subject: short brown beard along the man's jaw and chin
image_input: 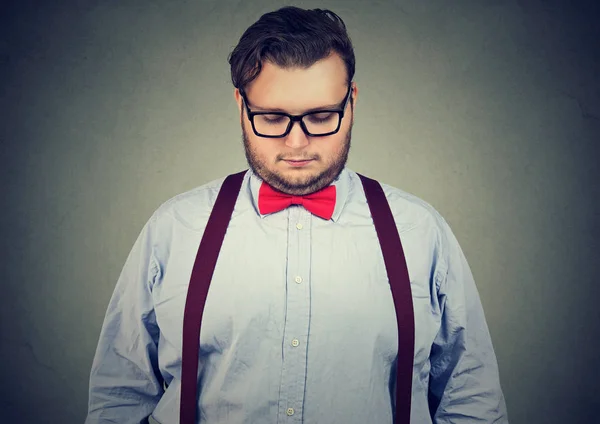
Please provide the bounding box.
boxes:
[242,122,353,196]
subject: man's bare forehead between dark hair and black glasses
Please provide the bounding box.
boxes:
[245,54,348,113]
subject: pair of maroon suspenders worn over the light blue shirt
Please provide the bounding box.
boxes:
[180,171,415,424]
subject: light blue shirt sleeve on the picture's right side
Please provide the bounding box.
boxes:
[429,222,508,424]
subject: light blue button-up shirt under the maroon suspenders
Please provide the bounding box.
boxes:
[86,168,508,424]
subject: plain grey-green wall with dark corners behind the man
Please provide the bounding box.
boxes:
[0,0,600,424]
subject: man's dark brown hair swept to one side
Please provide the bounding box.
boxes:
[228,6,355,90]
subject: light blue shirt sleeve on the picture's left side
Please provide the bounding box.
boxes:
[85,218,164,424]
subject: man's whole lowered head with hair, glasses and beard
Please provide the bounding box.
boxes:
[229,7,358,195]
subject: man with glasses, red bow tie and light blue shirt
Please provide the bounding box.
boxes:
[86,7,507,424]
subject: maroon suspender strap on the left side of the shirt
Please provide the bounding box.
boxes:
[179,171,247,424]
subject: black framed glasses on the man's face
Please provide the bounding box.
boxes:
[240,84,352,138]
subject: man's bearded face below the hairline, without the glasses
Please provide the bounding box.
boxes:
[235,54,358,195]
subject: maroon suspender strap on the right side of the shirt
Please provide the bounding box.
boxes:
[358,174,415,424]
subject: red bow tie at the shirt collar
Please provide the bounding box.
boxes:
[258,182,336,220]
